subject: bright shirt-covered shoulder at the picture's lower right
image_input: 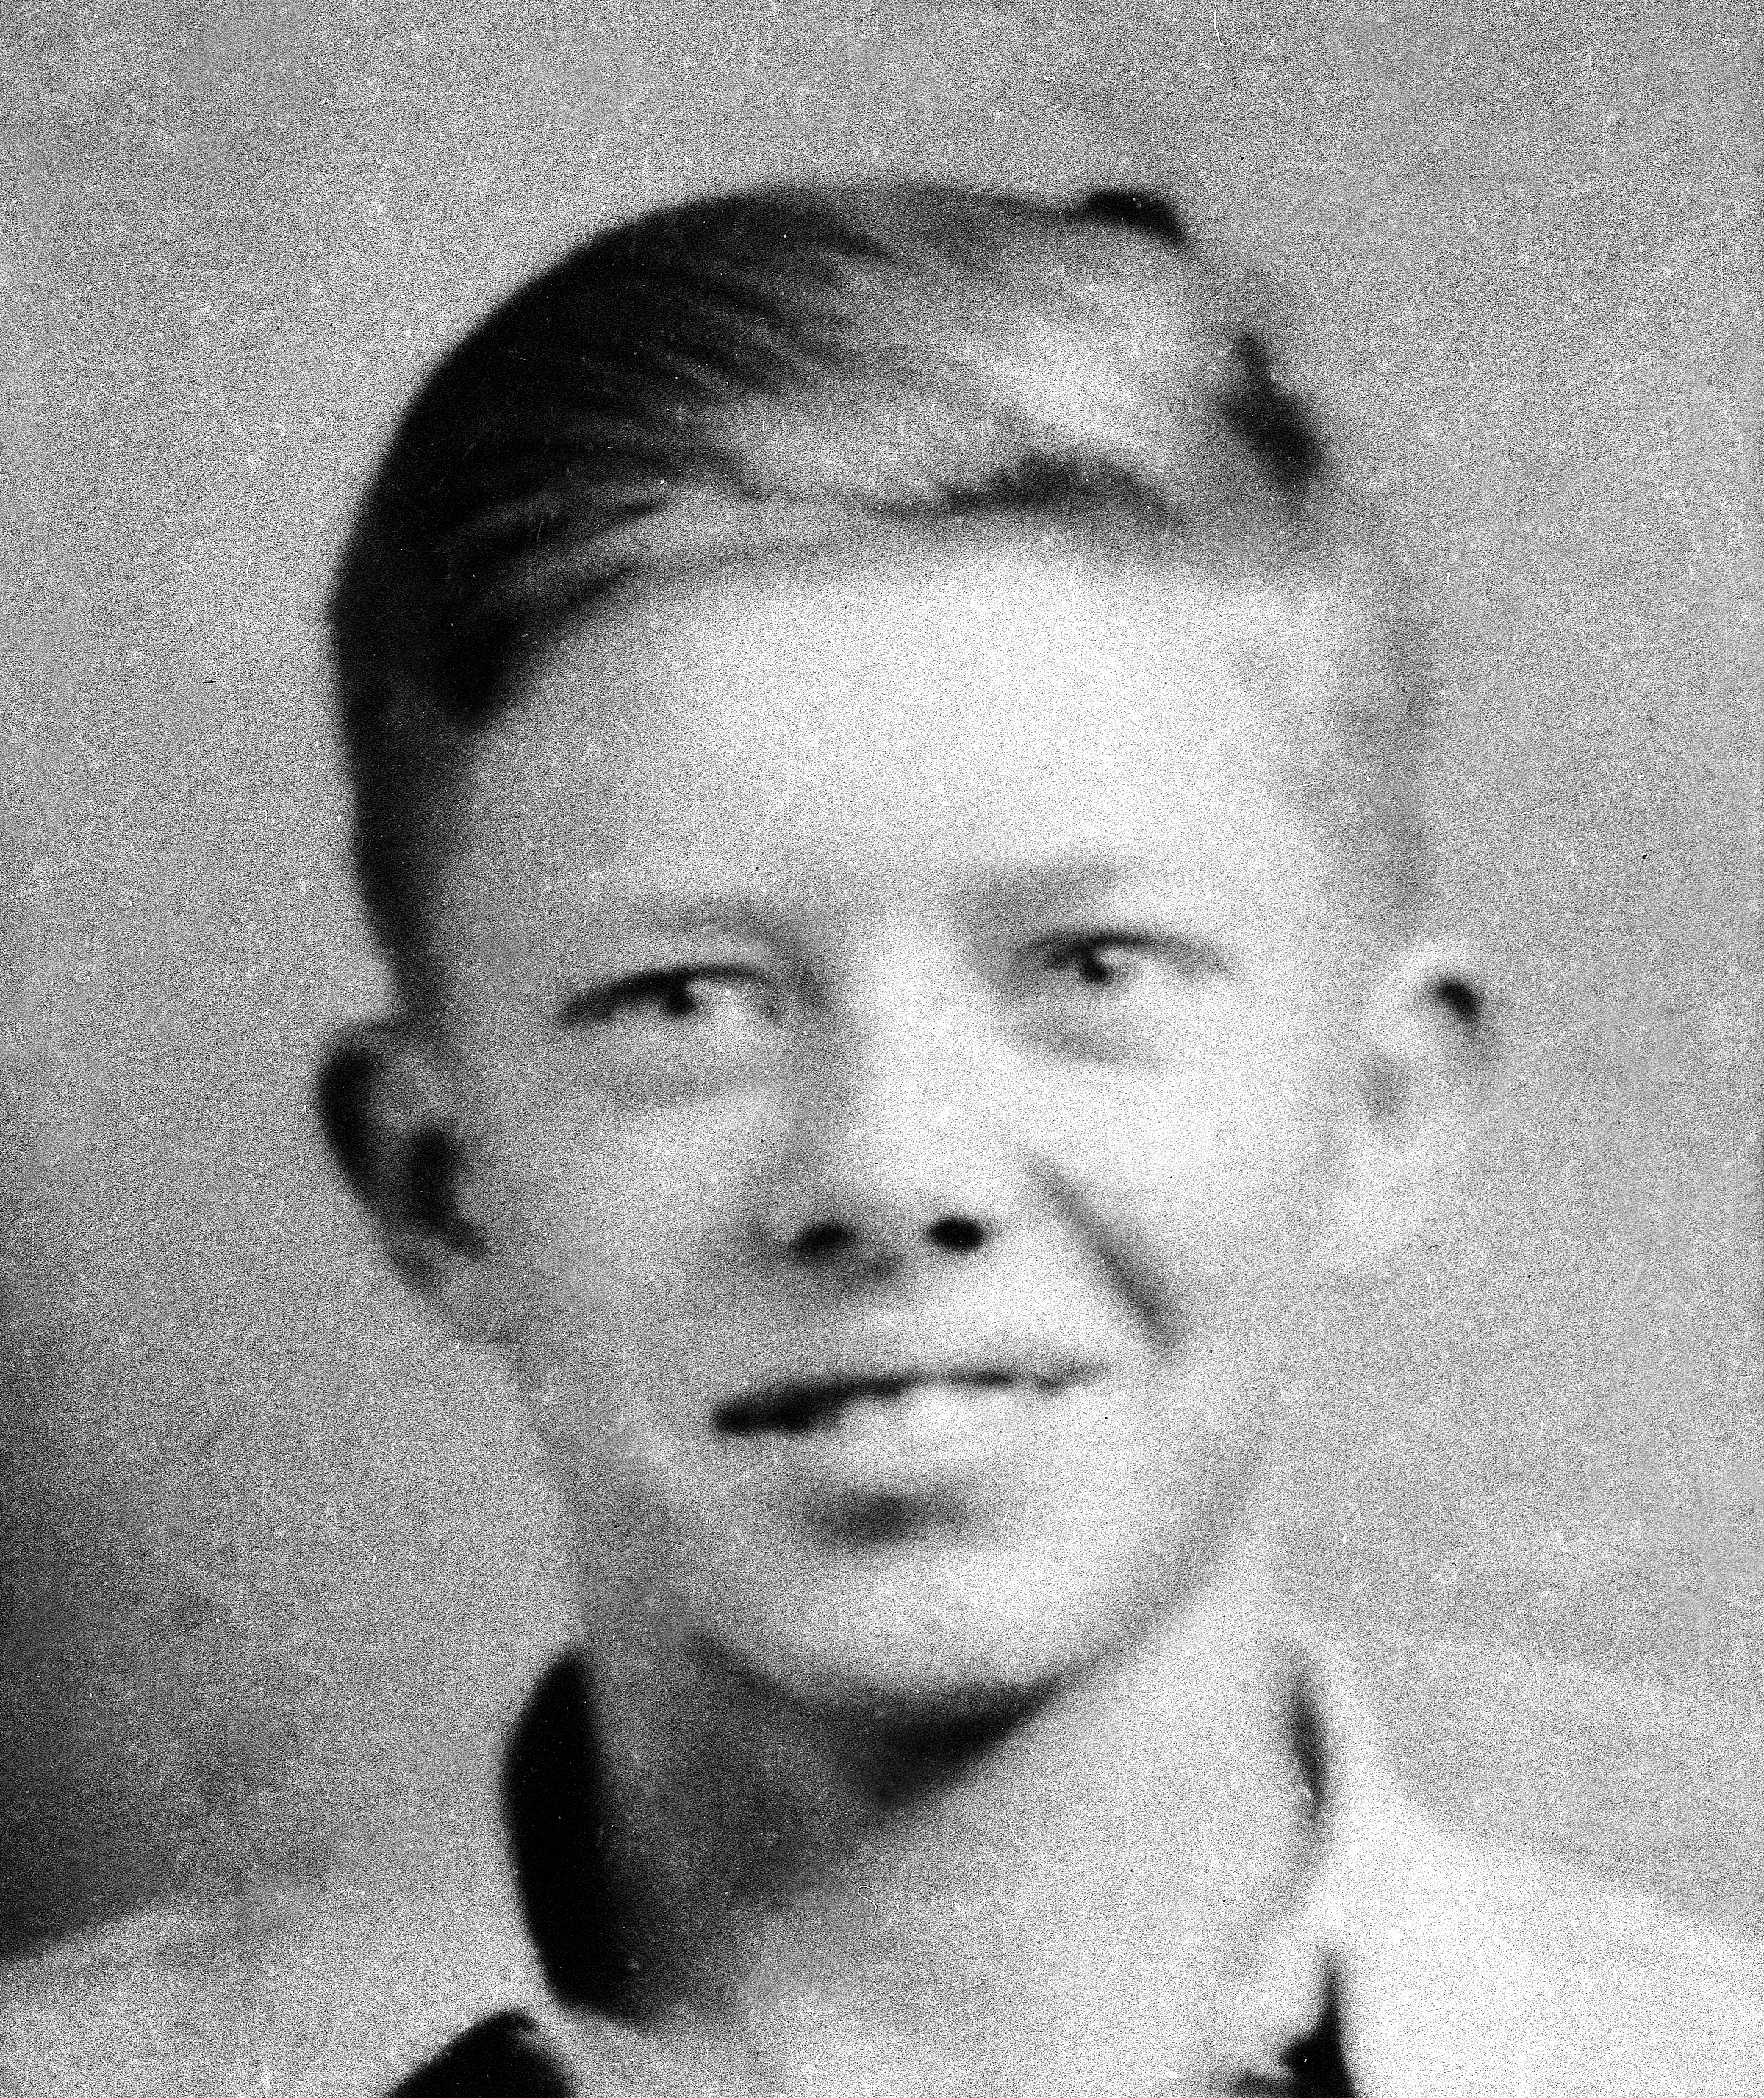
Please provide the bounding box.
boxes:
[1334,1762,1764,2098]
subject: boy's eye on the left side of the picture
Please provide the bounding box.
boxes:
[558,967,784,1086]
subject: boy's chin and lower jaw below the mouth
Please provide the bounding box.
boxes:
[566,1420,1256,1735]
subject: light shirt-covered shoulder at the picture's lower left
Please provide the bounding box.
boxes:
[0,1888,543,2098]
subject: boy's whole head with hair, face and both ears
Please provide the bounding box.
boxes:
[321,187,1477,1712]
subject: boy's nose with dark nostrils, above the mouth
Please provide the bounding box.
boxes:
[761,986,1015,1278]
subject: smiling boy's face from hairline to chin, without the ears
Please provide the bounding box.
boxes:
[398,531,1443,1712]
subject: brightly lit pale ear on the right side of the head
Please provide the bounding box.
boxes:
[1324,940,1489,1273]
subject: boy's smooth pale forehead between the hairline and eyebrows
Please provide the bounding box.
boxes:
[444,529,1376,948]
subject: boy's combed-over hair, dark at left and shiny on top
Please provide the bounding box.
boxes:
[329,182,1422,997]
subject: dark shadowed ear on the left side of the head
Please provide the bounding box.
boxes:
[312,1015,508,1341]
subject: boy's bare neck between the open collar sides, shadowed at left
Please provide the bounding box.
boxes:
[566,1540,1307,2098]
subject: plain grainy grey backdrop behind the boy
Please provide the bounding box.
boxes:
[0,0,1764,1945]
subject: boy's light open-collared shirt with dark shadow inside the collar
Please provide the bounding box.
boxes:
[0,1649,1764,2098]
